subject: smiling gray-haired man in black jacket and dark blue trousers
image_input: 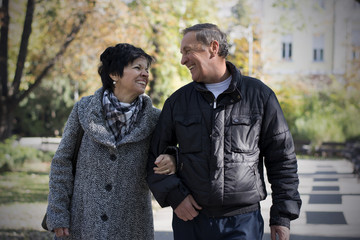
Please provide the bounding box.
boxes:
[147,23,301,240]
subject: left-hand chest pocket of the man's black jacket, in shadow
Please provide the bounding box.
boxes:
[175,115,201,153]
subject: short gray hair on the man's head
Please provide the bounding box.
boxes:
[182,23,229,58]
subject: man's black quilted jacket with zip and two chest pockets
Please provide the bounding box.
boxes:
[147,62,301,227]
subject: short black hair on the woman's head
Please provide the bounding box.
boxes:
[98,43,154,91]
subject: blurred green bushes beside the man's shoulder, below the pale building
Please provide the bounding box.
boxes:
[277,78,360,146]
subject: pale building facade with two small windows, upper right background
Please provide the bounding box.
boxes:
[252,0,360,81]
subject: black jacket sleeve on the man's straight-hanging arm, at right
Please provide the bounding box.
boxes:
[260,92,301,228]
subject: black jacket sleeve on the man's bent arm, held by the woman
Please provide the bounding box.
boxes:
[147,100,189,209]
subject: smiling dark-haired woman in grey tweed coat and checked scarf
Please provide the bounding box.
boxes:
[46,43,175,240]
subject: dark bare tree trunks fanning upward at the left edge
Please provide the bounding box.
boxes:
[0,0,95,141]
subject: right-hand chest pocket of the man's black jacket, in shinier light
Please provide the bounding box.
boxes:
[230,115,261,152]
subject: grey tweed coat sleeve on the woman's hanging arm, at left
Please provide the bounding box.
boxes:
[47,103,81,230]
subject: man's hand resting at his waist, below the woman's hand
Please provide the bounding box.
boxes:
[174,195,201,222]
